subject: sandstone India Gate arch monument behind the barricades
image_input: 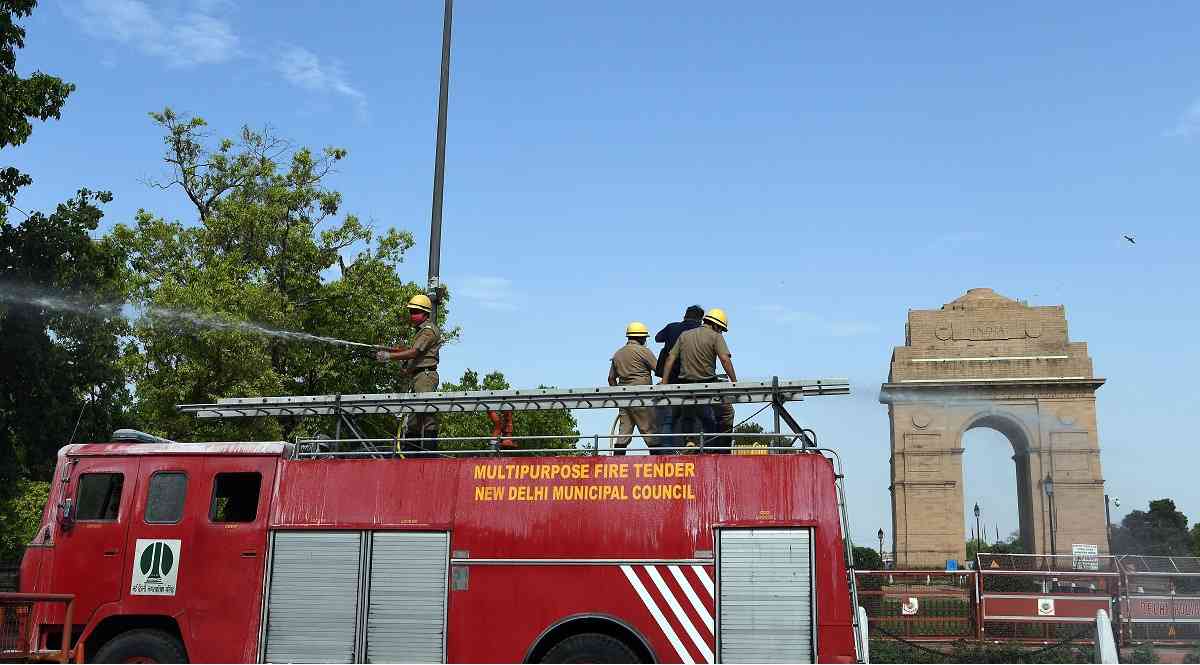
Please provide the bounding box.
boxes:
[880,288,1108,568]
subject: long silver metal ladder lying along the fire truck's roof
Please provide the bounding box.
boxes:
[178,378,850,418]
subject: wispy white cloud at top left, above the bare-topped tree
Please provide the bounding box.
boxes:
[67,0,238,67]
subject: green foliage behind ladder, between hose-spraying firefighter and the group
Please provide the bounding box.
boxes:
[438,370,580,450]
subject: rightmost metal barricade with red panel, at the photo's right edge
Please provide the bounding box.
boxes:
[1117,555,1200,643]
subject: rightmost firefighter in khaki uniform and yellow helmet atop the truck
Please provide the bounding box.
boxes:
[662,307,738,447]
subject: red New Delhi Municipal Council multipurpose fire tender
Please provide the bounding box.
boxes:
[20,374,862,664]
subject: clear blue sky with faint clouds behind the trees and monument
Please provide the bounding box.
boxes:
[6,0,1200,544]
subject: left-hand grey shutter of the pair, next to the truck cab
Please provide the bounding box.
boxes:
[265,532,362,663]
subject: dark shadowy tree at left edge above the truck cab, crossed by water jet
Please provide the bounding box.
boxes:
[0,190,130,484]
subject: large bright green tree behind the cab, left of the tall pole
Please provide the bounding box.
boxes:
[113,108,436,438]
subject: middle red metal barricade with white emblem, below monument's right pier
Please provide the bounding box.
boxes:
[976,552,1120,642]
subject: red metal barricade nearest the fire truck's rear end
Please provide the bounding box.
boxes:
[854,570,977,642]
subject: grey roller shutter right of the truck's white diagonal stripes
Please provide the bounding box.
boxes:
[716,528,815,663]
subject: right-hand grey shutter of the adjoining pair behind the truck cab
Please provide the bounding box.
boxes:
[366,532,450,663]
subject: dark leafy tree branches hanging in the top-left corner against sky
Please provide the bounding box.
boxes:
[0,0,74,213]
